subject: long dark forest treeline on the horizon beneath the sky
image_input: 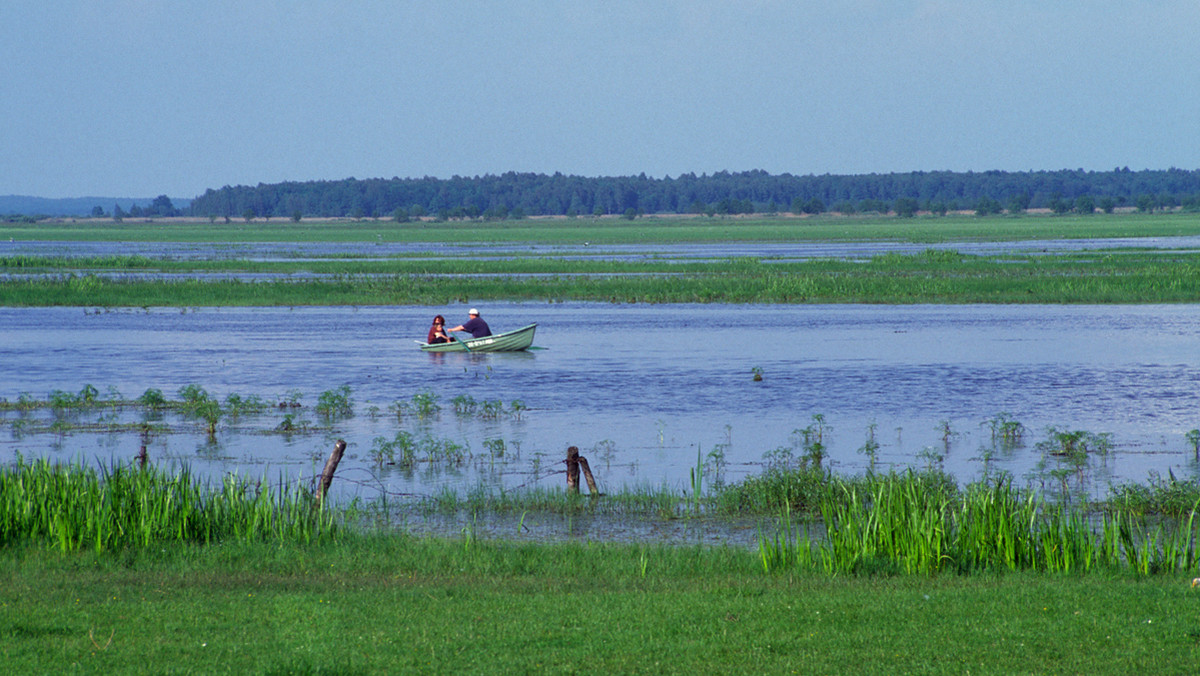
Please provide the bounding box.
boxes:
[188,168,1200,221]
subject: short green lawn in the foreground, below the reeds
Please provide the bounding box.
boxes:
[0,534,1200,674]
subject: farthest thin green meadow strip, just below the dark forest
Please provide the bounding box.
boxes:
[7,213,1200,245]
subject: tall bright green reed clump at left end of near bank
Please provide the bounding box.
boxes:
[0,459,338,551]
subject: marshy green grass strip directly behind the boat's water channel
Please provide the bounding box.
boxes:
[7,252,1200,307]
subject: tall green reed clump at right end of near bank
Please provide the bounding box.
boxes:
[758,471,1200,575]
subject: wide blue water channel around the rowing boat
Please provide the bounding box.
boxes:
[0,303,1200,509]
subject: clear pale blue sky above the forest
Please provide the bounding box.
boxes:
[0,0,1200,198]
